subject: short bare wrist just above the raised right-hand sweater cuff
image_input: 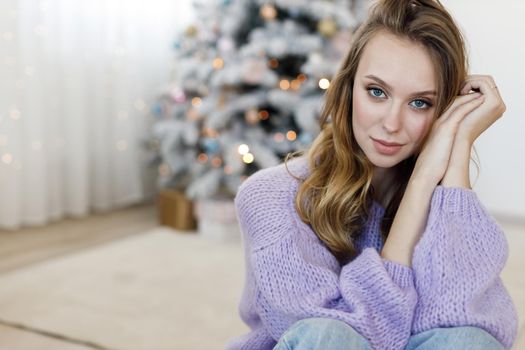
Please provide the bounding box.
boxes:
[441,137,472,189]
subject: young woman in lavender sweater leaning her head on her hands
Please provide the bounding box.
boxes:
[228,0,517,350]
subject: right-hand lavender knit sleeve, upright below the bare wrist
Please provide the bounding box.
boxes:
[412,186,517,349]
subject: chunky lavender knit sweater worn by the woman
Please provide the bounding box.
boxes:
[227,157,517,350]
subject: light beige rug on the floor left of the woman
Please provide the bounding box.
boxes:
[0,228,246,350]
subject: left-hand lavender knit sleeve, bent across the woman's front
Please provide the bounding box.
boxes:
[235,167,416,350]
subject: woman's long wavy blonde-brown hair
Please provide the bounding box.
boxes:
[286,0,468,263]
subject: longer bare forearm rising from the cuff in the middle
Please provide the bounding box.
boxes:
[381,177,435,266]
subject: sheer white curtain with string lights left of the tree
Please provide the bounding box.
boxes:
[0,0,183,229]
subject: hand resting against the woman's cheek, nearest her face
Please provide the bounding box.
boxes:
[410,91,485,190]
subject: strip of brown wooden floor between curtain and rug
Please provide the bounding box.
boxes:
[0,204,158,273]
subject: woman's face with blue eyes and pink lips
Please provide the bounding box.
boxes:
[352,31,436,168]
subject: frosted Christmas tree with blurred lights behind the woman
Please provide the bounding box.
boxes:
[147,0,367,198]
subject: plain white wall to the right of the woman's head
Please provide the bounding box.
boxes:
[442,0,525,219]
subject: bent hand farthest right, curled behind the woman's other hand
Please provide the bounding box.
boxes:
[457,75,506,146]
